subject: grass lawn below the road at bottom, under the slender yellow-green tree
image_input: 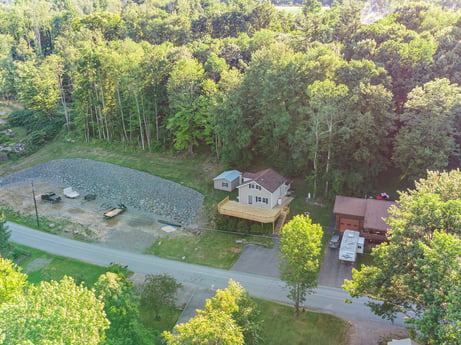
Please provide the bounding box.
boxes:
[255,299,350,345]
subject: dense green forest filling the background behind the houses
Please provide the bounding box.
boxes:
[0,0,461,197]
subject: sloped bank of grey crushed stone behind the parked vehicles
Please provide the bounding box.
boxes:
[0,159,203,225]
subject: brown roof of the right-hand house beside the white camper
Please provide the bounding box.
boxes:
[333,195,397,231]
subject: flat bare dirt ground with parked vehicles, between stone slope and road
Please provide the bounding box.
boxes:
[0,182,178,252]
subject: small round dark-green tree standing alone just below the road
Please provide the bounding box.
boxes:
[140,273,182,320]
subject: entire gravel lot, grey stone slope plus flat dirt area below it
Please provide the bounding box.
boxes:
[0,159,203,252]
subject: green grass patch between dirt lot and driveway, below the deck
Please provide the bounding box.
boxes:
[147,231,273,269]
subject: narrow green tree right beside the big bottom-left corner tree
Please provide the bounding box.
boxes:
[94,272,141,345]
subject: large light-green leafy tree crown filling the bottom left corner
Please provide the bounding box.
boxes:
[0,277,109,345]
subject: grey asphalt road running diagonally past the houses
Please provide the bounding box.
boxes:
[7,222,403,326]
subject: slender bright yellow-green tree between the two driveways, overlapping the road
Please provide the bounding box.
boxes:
[280,215,323,316]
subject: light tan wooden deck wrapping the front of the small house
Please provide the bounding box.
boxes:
[218,197,293,223]
